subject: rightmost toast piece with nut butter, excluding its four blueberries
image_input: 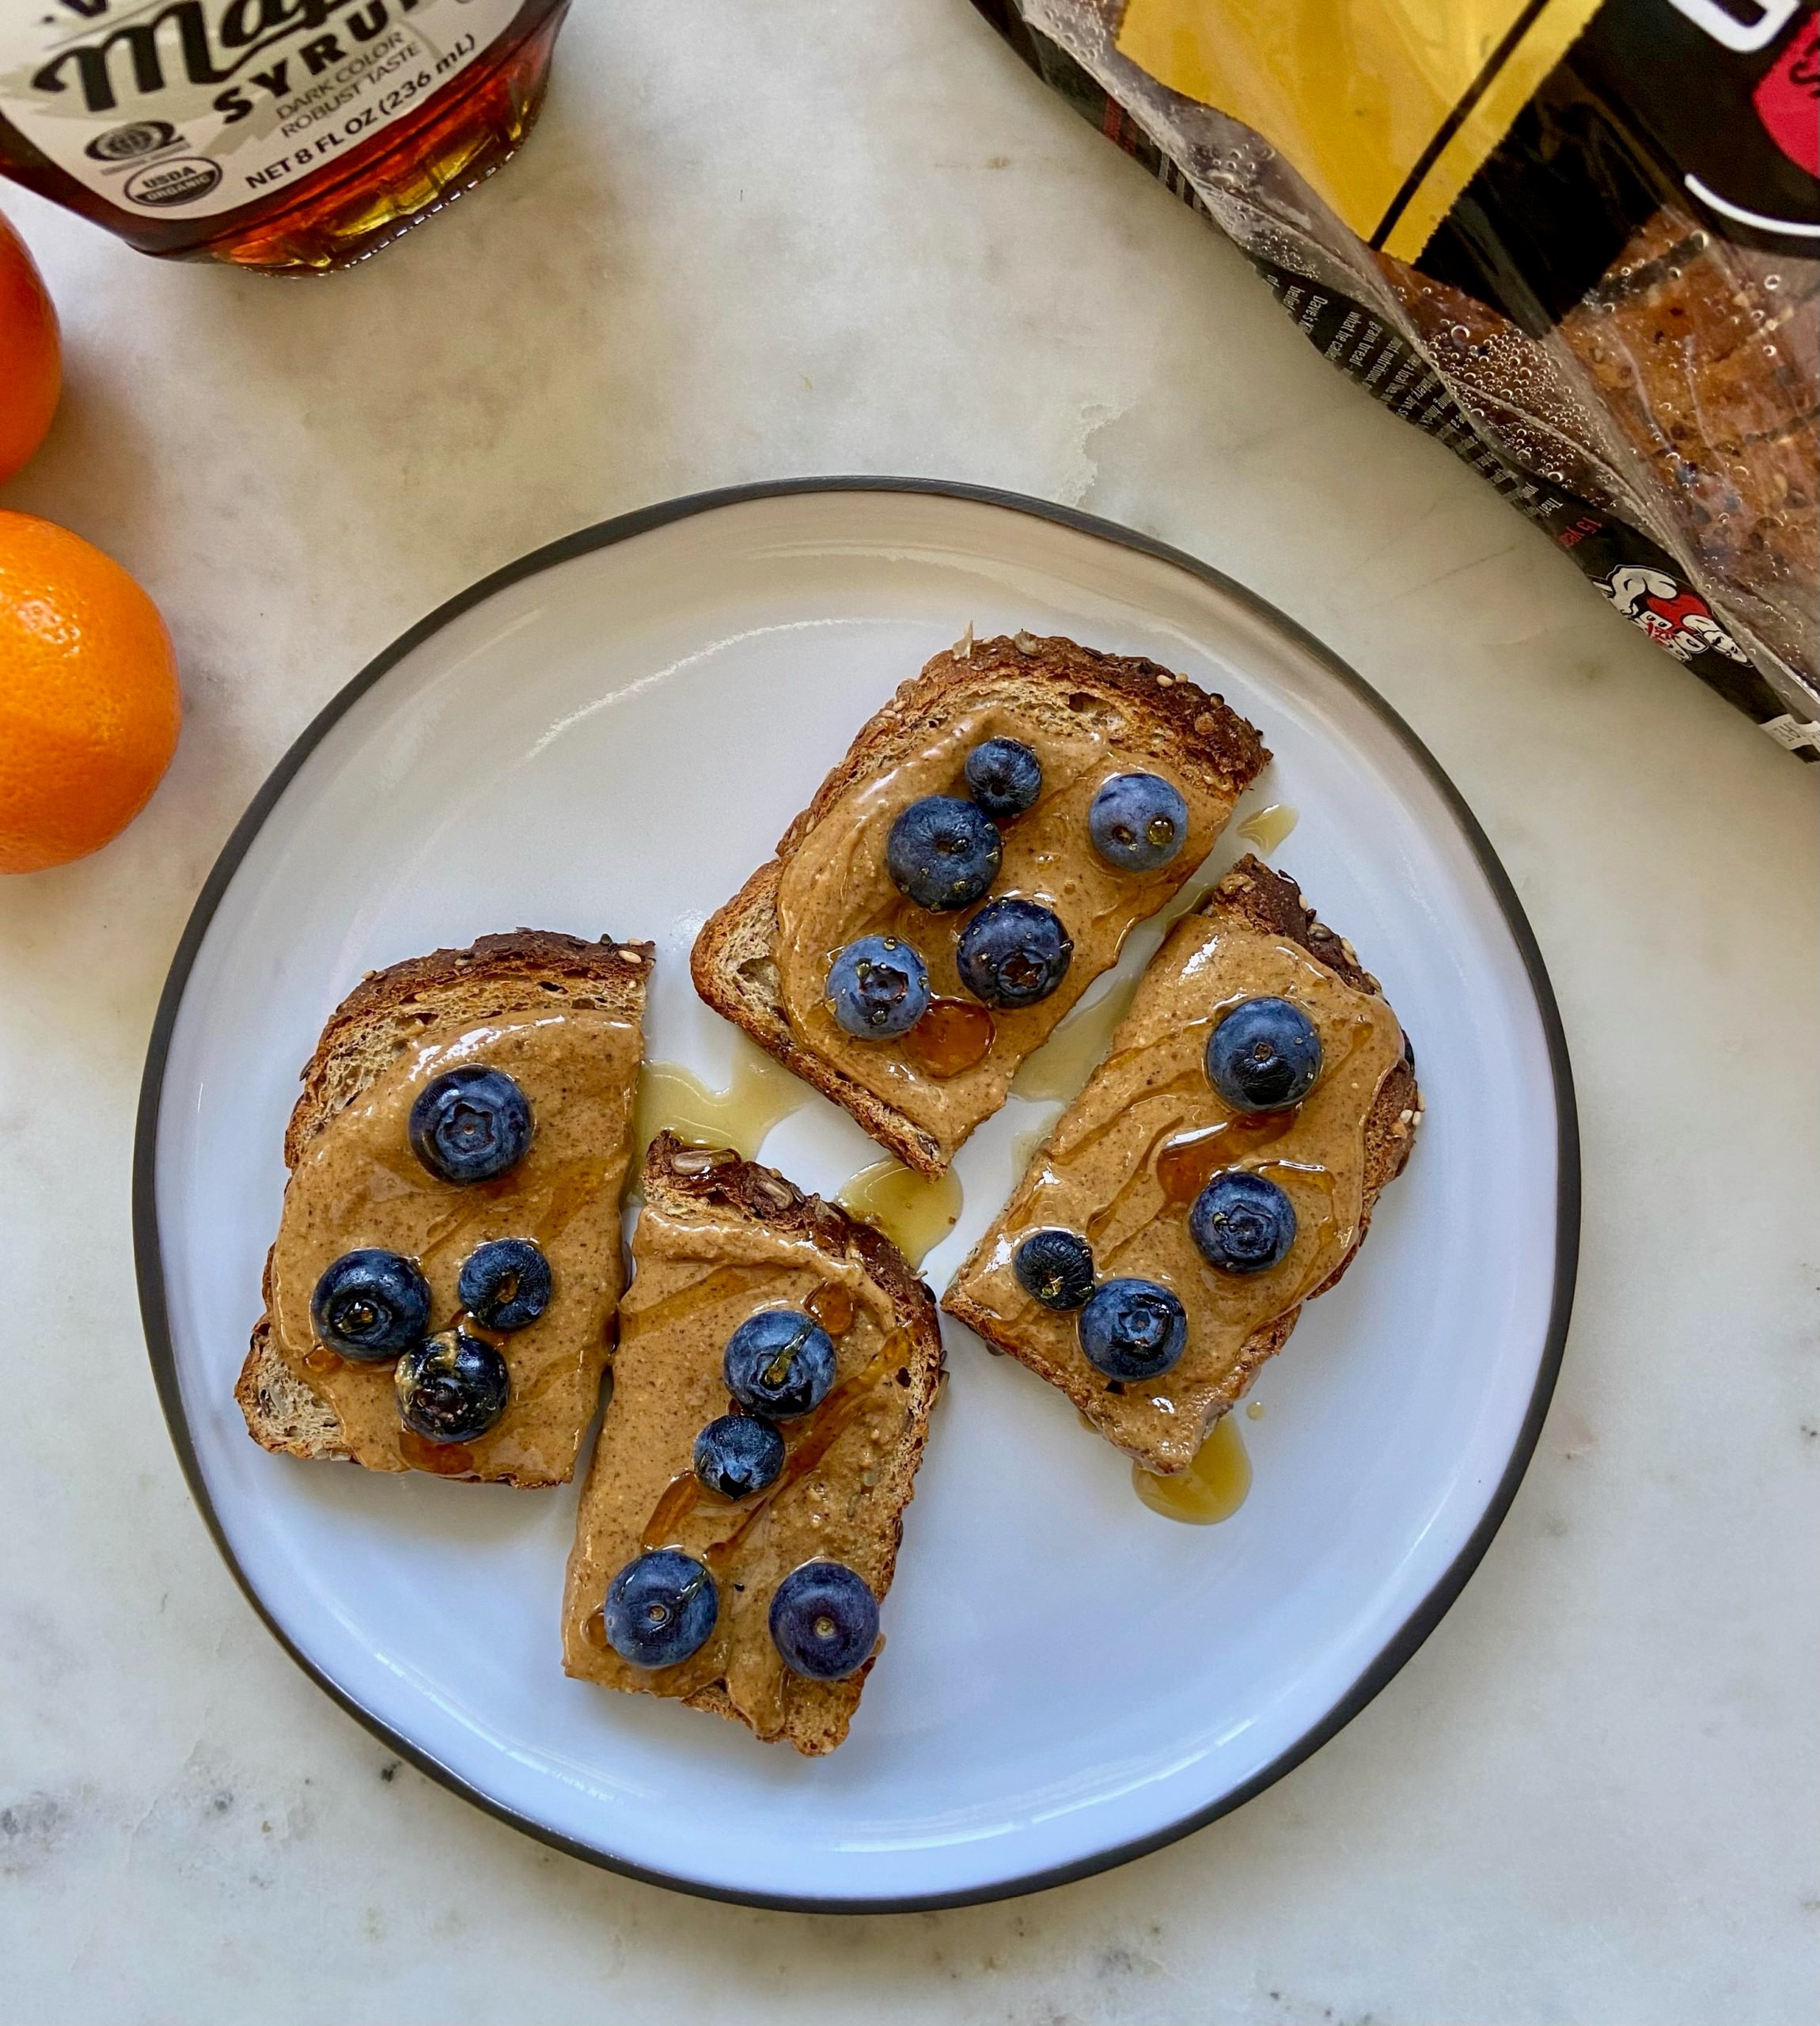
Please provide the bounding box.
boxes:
[942,857,1423,1473]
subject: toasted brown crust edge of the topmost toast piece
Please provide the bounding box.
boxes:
[689,634,1271,1177]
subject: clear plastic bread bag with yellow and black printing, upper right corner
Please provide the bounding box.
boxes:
[975,0,1820,760]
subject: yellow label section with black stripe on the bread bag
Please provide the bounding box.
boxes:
[1119,0,1599,261]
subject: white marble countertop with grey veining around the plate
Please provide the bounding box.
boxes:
[0,0,1820,2026]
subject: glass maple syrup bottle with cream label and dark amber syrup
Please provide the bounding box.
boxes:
[0,0,567,274]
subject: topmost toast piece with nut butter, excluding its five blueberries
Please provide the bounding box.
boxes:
[689,634,1268,1175]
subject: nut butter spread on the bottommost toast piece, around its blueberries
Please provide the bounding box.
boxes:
[563,1204,912,1738]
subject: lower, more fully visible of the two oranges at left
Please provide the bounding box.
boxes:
[0,513,183,873]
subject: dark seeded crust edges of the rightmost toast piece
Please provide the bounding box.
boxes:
[942,855,1423,1475]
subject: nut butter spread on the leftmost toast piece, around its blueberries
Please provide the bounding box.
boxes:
[267,1007,640,1483]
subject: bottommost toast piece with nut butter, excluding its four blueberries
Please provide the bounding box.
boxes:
[563,1133,942,1755]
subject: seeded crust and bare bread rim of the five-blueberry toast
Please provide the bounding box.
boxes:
[689,632,1271,1175]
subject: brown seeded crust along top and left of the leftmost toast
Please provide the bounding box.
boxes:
[233,928,654,1483]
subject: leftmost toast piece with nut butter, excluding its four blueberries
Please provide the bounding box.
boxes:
[235,928,653,1485]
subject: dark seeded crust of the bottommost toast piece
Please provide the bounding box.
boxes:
[587,1133,945,1759]
